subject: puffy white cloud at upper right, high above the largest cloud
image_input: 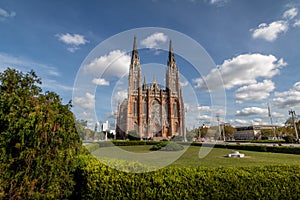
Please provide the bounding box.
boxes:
[251,20,289,42]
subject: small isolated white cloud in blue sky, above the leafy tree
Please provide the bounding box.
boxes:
[55,33,89,53]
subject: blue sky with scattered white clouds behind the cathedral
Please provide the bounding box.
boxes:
[0,0,300,129]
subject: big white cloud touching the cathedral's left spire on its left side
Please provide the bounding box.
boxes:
[83,50,130,77]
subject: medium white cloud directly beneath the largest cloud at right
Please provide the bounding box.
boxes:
[235,80,275,103]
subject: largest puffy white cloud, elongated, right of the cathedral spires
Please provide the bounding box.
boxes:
[194,53,286,90]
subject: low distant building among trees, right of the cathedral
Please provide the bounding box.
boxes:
[234,125,275,140]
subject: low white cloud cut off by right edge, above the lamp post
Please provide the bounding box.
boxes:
[273,82,300,108]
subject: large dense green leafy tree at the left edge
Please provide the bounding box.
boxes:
[0,68,81,199]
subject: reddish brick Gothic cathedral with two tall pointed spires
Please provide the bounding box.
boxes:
[116,37,185,139]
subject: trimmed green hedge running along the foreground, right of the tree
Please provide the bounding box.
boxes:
[73,156,300,199]
